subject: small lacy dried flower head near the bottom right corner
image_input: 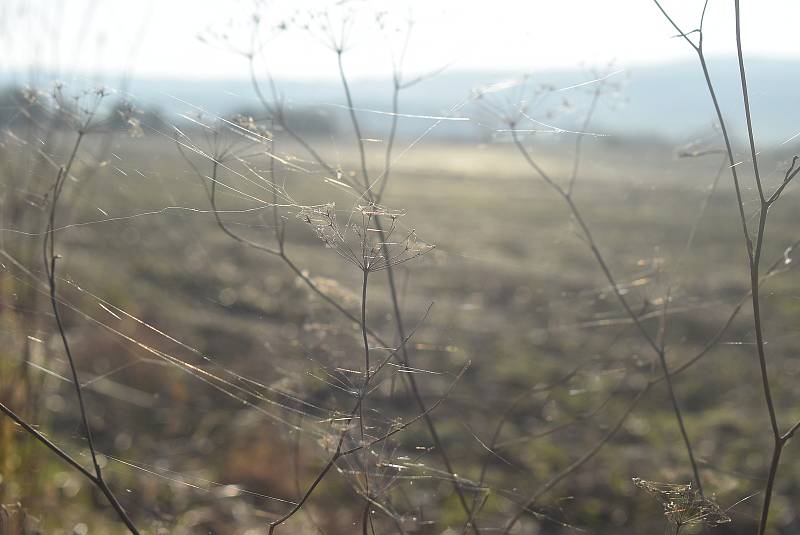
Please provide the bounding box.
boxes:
[633,477,731,528]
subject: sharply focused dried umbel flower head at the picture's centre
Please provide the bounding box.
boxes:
[298,203,434,272]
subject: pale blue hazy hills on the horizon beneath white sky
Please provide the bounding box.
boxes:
[0,58,800,143]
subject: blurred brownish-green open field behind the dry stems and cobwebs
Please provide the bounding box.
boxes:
[0,127,800,535]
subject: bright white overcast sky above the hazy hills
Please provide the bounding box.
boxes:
[0,0,800,78]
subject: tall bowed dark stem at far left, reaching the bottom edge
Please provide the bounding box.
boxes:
[38,130,139,535]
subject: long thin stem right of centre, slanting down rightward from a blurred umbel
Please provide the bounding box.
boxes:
[511,130,702,494]
